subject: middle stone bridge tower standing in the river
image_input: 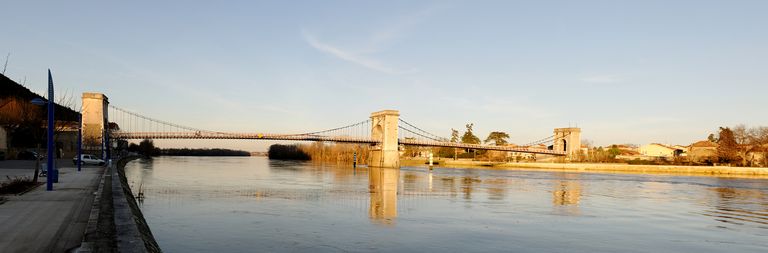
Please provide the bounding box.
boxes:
[368,110,400,168]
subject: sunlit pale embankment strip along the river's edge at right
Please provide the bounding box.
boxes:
[400,159,768,179]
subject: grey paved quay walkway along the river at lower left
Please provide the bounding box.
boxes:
[0,161,104,252]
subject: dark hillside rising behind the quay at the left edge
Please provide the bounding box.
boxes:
[0,74,80,121]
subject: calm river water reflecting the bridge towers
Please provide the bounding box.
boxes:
[126,157,768,252]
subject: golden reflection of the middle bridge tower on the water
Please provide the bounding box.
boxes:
[368,168,400,225]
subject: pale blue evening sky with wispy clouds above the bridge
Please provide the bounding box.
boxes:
[0,0,768,150]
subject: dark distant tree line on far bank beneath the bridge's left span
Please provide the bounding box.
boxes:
[127,140,251,156]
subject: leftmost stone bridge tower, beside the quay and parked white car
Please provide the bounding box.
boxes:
[80,92,109,160]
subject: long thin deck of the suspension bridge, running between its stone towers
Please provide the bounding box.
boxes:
[111,132,566,156]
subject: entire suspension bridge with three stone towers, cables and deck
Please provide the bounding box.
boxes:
[83,93,580,167]
